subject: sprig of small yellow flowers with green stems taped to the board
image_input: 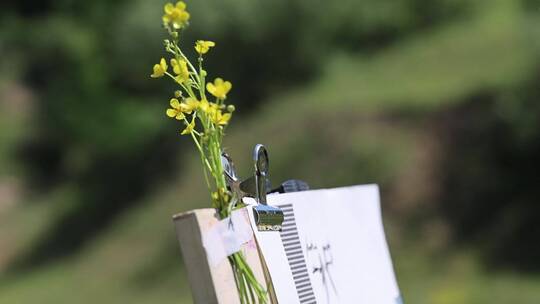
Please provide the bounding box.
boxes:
[150,1,267,303]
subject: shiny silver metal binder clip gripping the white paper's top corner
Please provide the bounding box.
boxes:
[221,144,284,231]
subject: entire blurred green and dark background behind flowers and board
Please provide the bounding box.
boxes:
[0,0,540,304]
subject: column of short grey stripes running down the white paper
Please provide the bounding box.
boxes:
[278,204,317,304]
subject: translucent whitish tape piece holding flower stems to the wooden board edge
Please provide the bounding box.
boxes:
[202,209,253,266]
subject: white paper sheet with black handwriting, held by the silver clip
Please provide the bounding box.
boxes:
[247,185,402,304]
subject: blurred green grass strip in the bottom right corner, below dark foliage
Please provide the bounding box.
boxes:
[394,247,540,304]
